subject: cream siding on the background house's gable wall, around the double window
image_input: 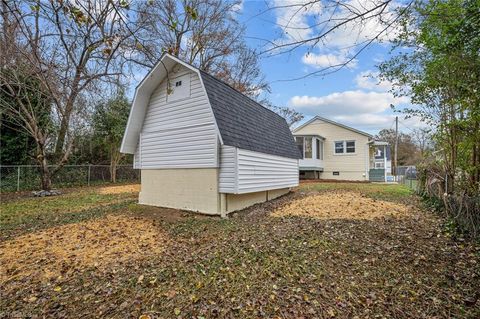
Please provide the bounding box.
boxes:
[294,119,369,181]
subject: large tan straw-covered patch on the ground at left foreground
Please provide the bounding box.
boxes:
[0,215,168,283]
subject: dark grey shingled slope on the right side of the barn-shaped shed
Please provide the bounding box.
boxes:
[200,71,301,159]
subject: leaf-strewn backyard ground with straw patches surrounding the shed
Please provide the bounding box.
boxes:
[0,183,480,318]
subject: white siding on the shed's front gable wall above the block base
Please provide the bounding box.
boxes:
[135,67,218,169]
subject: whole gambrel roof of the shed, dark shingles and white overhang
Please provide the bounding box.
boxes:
[121,54,301,159]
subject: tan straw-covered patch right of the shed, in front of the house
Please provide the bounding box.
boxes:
[272,191,409,220]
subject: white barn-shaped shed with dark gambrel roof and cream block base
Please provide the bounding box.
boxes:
[121,54,300,215]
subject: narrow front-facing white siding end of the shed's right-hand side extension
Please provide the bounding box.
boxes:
[219,145,237,193]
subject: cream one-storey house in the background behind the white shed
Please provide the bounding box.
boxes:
[293,116,391,181]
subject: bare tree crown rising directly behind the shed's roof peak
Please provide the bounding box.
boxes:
[133,0,269,97]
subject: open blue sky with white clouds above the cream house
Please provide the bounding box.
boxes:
[235,0,420,134]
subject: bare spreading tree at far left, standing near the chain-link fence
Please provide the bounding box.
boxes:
[0,0,131,189]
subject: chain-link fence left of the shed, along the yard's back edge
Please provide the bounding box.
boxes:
[0,165,140,192]
